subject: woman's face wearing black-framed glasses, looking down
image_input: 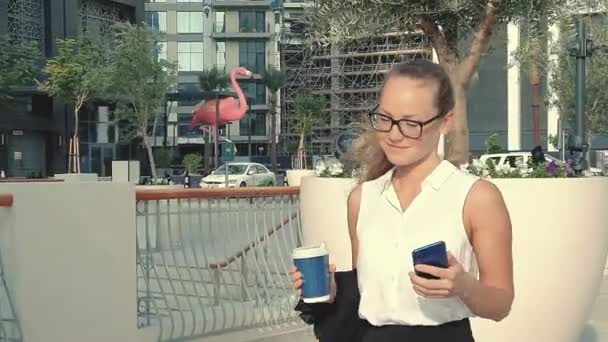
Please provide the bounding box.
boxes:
[372,76,452,166]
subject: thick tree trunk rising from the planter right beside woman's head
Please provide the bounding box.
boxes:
[445,82,469,166]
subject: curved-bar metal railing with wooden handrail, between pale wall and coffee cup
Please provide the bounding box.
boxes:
[136,188,301,341]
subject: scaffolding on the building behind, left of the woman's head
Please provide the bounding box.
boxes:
[280,28,432,155]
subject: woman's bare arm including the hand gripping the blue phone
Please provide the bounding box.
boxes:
[410,180,514,321]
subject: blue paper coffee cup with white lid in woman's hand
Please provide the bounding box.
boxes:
[293,245,330,303]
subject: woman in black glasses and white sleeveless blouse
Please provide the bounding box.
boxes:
[291,61,514,342]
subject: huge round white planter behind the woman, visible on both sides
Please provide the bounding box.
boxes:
[300,177,608,342]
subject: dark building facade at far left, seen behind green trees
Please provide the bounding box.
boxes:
[0,0,144,177]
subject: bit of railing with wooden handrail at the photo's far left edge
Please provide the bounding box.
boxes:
[0,194,23,342]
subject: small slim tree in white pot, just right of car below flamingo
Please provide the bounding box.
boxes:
[287,94,327,186]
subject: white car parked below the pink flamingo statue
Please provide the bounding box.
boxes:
[200,163,277,188]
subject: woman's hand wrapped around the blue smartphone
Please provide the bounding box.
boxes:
[410,252,475,298]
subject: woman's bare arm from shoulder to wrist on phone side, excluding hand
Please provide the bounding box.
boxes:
[460,180,515,321]
